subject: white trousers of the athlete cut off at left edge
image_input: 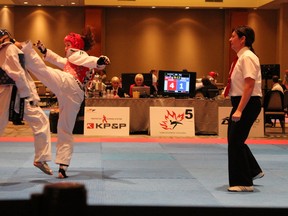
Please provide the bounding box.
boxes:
[0,85,51,162]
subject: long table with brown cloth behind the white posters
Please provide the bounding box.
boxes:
[85,98,231,135]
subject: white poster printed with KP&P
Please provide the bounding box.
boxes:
[84,107,130,136]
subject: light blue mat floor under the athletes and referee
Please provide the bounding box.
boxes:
[0,142,288,207]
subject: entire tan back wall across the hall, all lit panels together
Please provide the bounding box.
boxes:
[0,7,288,83]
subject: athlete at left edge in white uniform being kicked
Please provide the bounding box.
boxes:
[0,29,53,175]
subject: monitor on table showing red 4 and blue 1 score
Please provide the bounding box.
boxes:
[158,70,196,98]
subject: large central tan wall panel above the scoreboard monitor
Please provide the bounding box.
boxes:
[106,9,224,81]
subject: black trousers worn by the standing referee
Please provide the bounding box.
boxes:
[227,96,261,187]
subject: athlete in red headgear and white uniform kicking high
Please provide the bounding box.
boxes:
[21,27,110,178]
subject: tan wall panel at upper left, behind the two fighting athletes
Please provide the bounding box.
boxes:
[14,7,85,56]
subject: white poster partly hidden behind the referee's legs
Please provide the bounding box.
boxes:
[218,107,264,138]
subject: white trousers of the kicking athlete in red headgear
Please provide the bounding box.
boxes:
[22,43,84,165]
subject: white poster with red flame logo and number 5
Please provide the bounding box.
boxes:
[150,107,195,137]
